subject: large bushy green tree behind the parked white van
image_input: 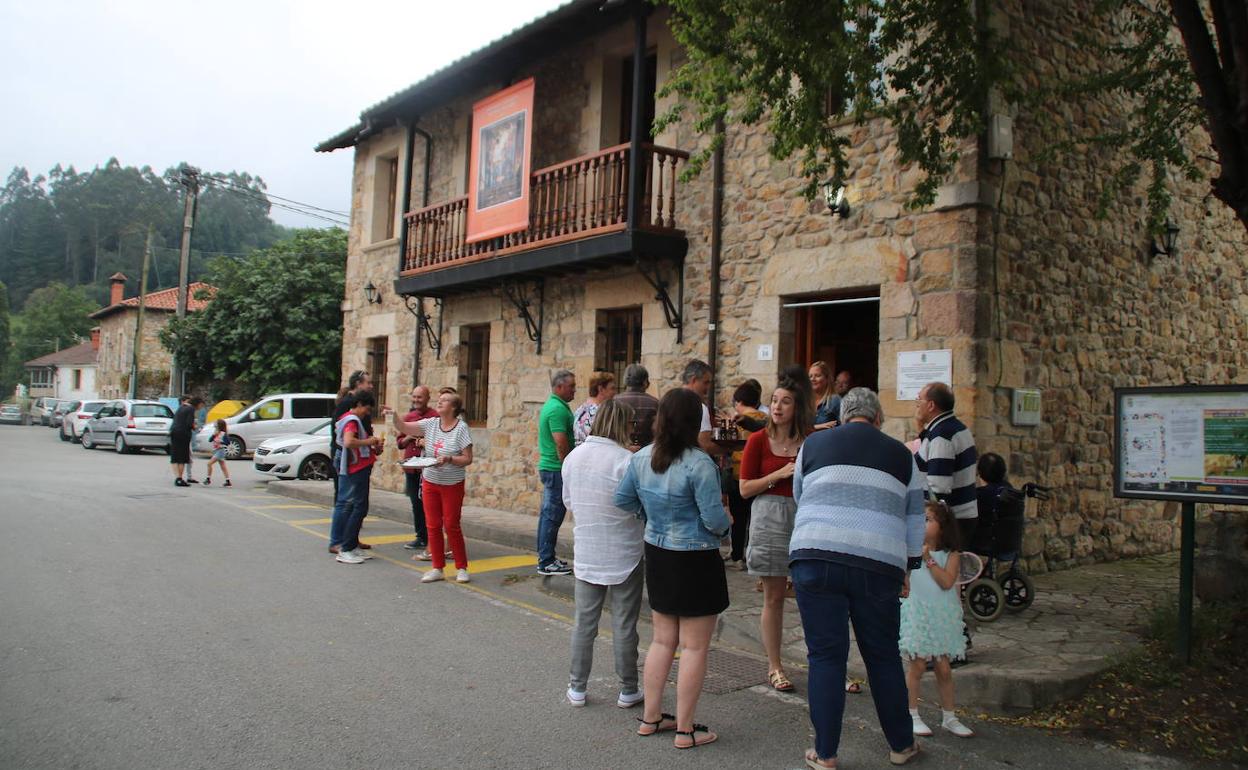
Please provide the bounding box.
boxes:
[161,228,347,397]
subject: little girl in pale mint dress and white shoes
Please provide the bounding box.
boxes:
[897,500,975,738]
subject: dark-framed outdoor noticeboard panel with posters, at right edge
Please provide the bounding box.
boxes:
[1113,384,1248,505]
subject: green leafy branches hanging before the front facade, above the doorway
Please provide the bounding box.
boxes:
[656,0,1010,205]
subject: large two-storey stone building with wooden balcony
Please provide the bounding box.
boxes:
[317,0,1248,570]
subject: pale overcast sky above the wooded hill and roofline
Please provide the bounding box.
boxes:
[0,0,562,227]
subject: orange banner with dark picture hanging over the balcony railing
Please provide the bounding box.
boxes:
[468,77,534,243]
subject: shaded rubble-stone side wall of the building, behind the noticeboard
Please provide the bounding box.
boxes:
[975,0,1248,569]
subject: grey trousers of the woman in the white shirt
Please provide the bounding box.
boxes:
[572,559,645,694]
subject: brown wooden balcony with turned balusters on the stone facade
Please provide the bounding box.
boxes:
[398,144,689,296]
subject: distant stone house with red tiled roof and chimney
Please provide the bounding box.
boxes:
[91,273,212,398]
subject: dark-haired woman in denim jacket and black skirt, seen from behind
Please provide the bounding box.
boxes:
[615,388,731,749]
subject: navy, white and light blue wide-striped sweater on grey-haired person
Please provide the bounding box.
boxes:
[789,422,925,580]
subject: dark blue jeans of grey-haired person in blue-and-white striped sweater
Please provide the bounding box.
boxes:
[790,559,915,759]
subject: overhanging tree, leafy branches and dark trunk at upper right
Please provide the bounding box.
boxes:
[655,0,1248,234]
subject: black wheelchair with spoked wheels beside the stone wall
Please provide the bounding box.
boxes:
[962,483,1051,623]
